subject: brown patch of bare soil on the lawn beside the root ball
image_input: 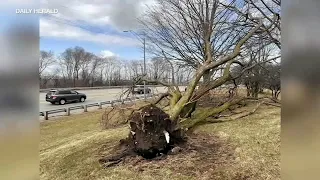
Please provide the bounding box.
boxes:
[100,133,247,180]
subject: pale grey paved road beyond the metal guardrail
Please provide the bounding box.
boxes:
[39,86,184,112]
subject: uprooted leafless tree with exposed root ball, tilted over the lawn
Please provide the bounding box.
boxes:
[99,0,279,165]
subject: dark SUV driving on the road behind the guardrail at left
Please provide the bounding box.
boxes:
[46,90,87,105]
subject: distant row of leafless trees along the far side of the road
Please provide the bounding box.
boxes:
[39,47,193,88]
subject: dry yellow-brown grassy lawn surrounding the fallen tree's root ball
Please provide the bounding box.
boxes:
[40,105,280,180]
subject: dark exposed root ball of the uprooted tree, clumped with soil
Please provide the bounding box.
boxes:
[100,105,185,164]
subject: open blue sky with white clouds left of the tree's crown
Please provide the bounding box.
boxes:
[40,0,154,60]
